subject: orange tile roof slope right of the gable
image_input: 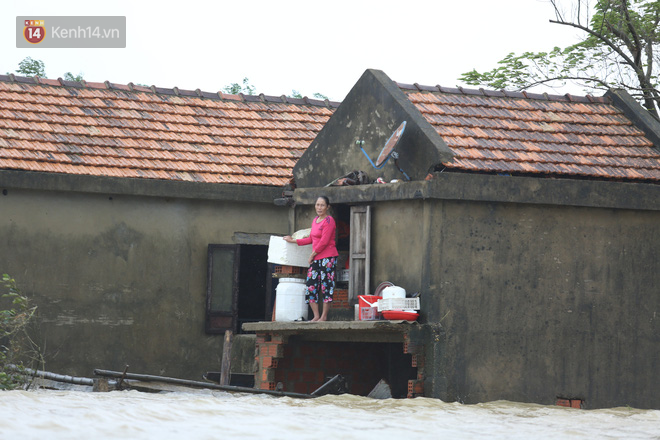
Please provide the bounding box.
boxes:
[397,84,660,182]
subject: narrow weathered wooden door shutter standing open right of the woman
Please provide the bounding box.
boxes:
[348,205,371,301]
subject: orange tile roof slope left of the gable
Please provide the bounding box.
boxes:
[0,75,339,186]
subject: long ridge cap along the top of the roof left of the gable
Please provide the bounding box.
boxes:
[0,73,341,108]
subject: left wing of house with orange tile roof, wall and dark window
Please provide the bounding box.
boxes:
[0,75,337,379]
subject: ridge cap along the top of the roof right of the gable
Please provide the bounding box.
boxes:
[394,81,611,104]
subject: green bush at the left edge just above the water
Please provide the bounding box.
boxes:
[0,274,43,390]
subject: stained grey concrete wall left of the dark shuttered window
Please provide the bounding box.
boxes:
[0,176,288,379]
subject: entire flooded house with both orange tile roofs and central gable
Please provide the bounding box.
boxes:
[0,70,660,408]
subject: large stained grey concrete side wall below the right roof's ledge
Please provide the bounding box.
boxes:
[423,201,660,408]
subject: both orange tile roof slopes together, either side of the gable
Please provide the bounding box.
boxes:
[5,75,660,186]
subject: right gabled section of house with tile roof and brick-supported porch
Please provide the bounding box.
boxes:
[244,70,660,408]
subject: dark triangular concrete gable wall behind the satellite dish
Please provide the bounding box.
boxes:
[293,69,453,188]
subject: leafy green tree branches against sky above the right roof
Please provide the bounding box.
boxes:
[460,0,660,117]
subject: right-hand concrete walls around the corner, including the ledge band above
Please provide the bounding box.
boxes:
[296,174,660,408]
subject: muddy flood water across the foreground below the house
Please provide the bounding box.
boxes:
[0,390,660,440]
